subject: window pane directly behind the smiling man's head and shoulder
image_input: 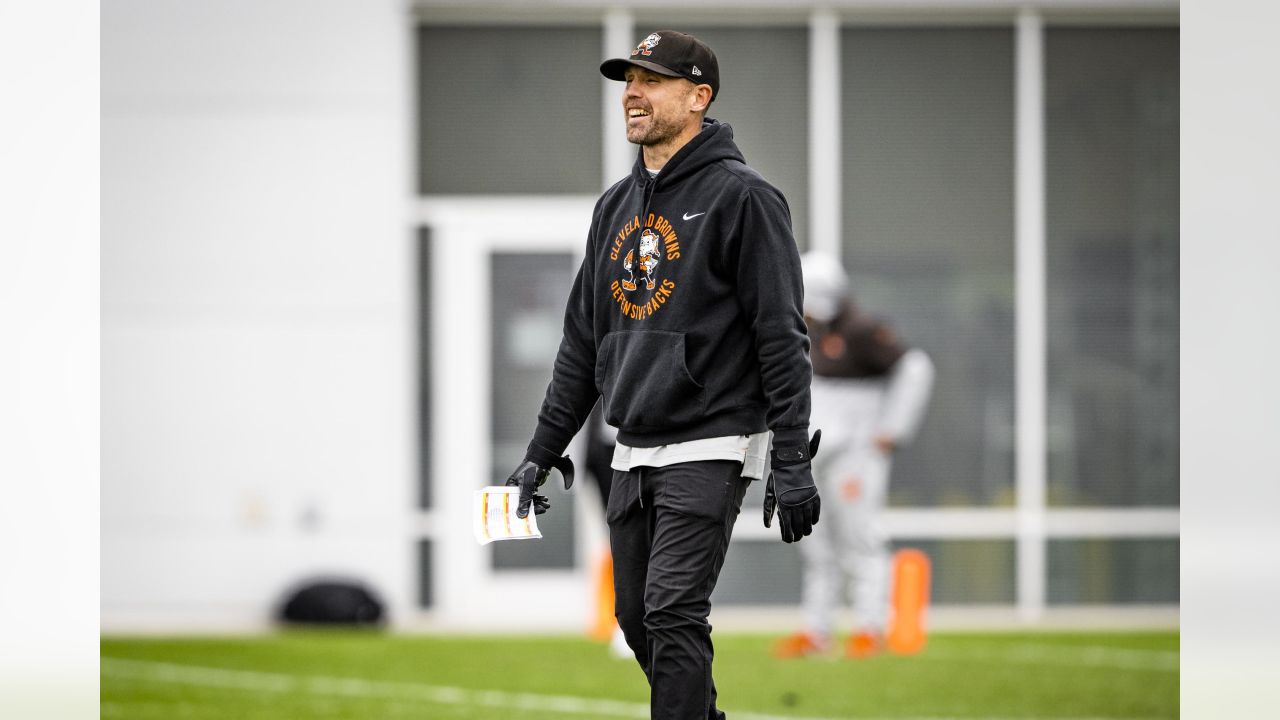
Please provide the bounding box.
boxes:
[660,23,809,249]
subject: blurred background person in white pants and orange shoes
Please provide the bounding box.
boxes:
[774,251,933,657]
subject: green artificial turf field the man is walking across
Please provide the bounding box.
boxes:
[101,630,1179,720]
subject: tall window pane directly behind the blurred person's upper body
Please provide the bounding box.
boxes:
[841,28,1014,506]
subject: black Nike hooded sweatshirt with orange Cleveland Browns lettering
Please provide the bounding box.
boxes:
[529,119,812,468]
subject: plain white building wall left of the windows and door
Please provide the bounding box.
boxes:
[101,0,416,630]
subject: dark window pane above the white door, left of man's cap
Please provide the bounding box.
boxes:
[417,26,603,195]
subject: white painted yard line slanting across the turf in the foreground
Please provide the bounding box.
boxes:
[101,657,1172,720]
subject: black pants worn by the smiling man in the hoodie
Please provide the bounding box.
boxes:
[605,460,750,720]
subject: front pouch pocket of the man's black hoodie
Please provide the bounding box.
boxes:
[595,331,707,428]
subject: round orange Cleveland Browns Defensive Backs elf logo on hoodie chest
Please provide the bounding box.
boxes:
[609,213,680,320]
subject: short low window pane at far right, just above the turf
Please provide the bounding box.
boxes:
[1048,538,1179,605]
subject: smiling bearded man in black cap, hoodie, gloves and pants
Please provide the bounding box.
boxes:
[507,31,819,720]
